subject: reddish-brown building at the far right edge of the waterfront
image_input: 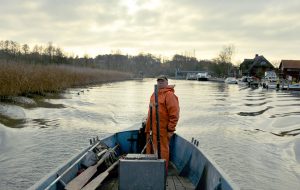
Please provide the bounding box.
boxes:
[279,60,300,82]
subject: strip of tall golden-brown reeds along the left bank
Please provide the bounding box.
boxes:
[0,62,131,97]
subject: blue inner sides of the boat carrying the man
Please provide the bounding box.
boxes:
[30,130,239,190]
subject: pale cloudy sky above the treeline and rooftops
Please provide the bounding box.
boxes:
[0,0,300,63]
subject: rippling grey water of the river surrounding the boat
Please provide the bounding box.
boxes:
[0,79,300,190]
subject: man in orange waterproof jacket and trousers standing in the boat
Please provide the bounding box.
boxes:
[145,75,180,169]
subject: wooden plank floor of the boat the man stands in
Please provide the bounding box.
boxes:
[97,163,195,190]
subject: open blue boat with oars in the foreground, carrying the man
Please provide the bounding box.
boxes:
[30,125,239,190]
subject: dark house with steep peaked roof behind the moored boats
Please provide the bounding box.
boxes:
[240,54,275,78]
